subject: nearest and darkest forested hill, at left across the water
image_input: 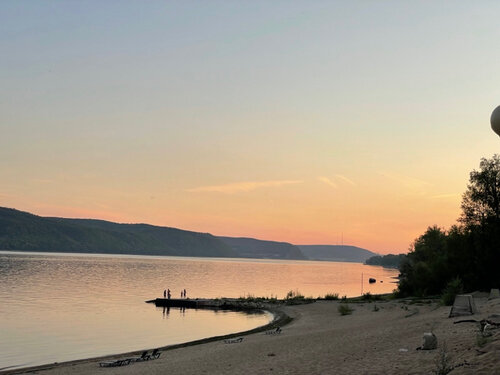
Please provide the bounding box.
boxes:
[0,207,238,257]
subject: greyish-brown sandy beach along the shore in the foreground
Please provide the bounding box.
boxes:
[6,297,500,375]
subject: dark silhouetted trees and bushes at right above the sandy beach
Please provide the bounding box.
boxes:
[399,155,500,296]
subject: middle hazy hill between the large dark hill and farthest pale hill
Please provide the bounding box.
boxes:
[218,237,307,259]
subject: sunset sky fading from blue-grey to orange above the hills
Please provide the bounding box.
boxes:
[0,0,500,254]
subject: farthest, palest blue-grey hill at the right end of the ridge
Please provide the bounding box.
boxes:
[297,245,378,263]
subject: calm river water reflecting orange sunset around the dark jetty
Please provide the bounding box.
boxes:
[0,252,398,371]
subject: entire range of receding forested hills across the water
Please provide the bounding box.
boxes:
[0,207,376,262]
